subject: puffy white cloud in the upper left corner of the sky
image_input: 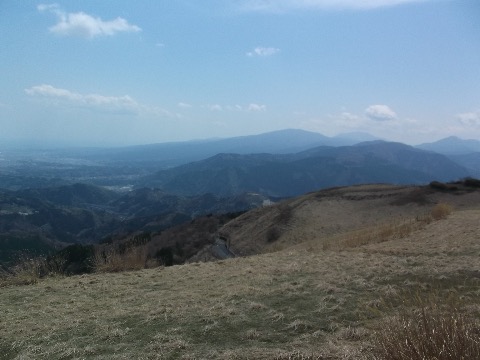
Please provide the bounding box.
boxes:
[37,4,141,39]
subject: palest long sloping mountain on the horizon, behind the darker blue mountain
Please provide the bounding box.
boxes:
[32,129,377,168]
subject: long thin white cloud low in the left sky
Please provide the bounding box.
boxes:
[25,84,172,116]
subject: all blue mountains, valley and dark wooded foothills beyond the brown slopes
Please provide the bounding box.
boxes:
[0,130,480,264]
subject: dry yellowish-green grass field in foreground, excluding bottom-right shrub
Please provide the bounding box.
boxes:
[0,204,480,359]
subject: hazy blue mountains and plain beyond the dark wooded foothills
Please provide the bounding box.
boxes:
[0,129,480,197]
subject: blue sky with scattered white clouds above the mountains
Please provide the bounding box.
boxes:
[0,0,480,146]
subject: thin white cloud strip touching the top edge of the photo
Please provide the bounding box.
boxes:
[240,0,432,12]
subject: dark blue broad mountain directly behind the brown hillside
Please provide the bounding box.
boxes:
[139,141,470,197]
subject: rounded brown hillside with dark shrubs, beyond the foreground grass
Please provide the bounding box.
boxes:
[219,185,480,256]
